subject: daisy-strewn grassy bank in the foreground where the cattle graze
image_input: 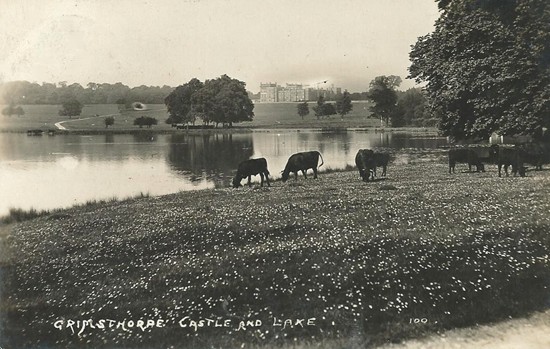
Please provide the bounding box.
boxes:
[0,151,550,348]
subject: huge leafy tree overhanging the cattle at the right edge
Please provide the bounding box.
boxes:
[409,0,550,139]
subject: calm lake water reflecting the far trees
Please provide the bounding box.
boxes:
[0,130,445,215]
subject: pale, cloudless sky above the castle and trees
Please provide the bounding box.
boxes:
[0,0,439,92]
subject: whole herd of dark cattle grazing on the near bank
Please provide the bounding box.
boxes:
[233,143,550,188]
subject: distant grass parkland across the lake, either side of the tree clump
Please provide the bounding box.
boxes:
[0,101,392,132]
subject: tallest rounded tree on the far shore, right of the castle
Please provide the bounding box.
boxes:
[367,75,401,125]
